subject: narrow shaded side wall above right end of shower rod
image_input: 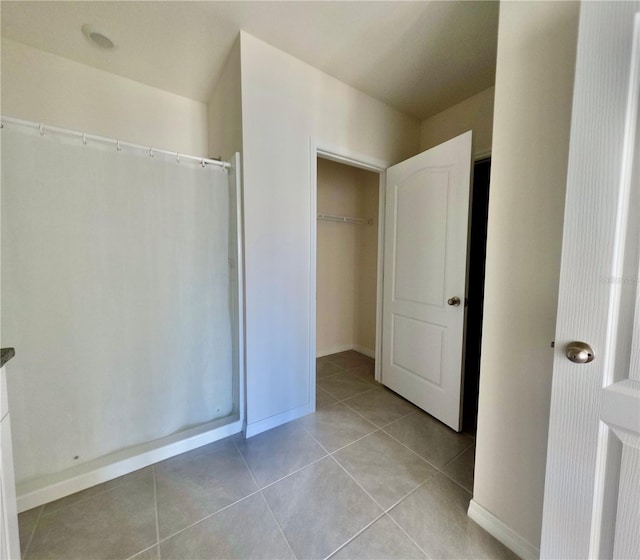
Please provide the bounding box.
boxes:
[207,36,242,161]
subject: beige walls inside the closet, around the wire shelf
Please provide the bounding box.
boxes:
[316,159,379,356]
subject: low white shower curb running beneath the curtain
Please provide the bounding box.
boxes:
[16,418,242,512]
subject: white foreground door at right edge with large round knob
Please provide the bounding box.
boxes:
[540,1,640,559]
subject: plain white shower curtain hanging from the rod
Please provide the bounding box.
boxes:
[1,125,236,483]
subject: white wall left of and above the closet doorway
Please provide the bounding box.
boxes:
[241,32,419,435]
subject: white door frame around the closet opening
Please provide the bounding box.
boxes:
[309,136,391,406]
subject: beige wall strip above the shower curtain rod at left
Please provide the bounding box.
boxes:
[2,39,208,156]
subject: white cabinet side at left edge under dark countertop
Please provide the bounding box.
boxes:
[0,367,20,560]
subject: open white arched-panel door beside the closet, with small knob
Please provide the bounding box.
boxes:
[381,132,471,431]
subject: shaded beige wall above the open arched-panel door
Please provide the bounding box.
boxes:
[420,87,495,156]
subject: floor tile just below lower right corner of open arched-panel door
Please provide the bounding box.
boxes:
[384,412,474,467]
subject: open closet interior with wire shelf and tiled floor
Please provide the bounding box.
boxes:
[315,157,381,396]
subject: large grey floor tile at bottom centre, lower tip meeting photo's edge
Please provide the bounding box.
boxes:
[263,457,382,559]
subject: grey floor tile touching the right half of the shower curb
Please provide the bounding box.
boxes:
[155,441,257,539]
